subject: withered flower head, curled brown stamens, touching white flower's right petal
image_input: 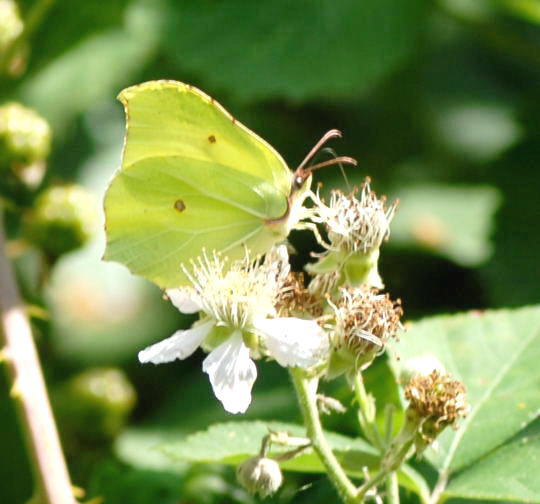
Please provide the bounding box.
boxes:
[328,287,403,378]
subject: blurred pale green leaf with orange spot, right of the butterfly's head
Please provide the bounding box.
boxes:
[392,185,500,266]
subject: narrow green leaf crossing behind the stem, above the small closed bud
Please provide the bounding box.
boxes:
[162,421,378,476]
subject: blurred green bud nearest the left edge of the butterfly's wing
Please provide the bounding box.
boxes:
[23,185,97,259]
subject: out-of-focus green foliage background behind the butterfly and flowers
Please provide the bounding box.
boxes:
[0,0,540,504]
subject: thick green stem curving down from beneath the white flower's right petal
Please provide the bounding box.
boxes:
[290,368,360,504]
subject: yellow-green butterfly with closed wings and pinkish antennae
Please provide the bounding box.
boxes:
[104,80,355,288]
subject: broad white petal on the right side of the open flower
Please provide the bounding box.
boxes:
[254,317,329,367]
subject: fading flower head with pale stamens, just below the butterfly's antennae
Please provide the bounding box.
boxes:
[307,178,397,288]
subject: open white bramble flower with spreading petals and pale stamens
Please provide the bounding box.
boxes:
[139,246,329,413]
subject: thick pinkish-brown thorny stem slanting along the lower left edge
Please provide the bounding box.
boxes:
[0,212,75,504]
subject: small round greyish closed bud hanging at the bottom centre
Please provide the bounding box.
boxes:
[236,455,283,499]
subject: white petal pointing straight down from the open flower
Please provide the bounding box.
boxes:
[203,331,257,413]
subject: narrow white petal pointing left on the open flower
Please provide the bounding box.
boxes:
[139,320,214,364]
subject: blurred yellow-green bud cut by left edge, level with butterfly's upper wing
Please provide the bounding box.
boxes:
[0,102,51,165]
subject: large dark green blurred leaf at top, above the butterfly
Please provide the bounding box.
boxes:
[162,0,427,101]
